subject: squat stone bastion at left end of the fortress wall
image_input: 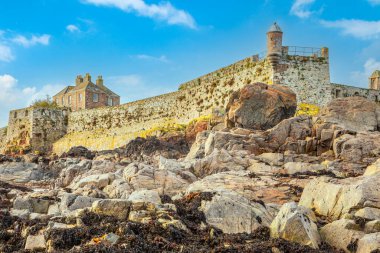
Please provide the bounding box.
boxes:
[0,107,68,152]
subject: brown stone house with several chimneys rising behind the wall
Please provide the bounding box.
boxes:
[53,73,120,111]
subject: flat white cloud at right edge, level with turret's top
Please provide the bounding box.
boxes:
[321,19,380,39]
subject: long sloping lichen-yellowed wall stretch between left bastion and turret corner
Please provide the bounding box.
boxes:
[54,57,272,154]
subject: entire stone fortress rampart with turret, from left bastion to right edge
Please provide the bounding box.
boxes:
[0,25,380,154]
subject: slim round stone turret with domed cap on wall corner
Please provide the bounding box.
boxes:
[267,23,283,68]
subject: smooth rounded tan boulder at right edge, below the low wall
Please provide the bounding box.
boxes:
[320,97,380,132]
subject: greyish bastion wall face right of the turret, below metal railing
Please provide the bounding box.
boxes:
[273,55,333,106]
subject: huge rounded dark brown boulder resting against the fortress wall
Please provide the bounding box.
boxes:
[226,83,297,130]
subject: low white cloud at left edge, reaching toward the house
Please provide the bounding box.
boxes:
[0,74,64,127]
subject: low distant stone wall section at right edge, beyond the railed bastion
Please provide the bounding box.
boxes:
[331,83,380,102]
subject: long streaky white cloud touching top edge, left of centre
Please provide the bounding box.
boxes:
[82,0,196,29]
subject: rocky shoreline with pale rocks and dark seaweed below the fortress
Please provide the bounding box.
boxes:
[0,87,380,253]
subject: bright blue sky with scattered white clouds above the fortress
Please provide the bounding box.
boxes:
[0,0,380,126]
